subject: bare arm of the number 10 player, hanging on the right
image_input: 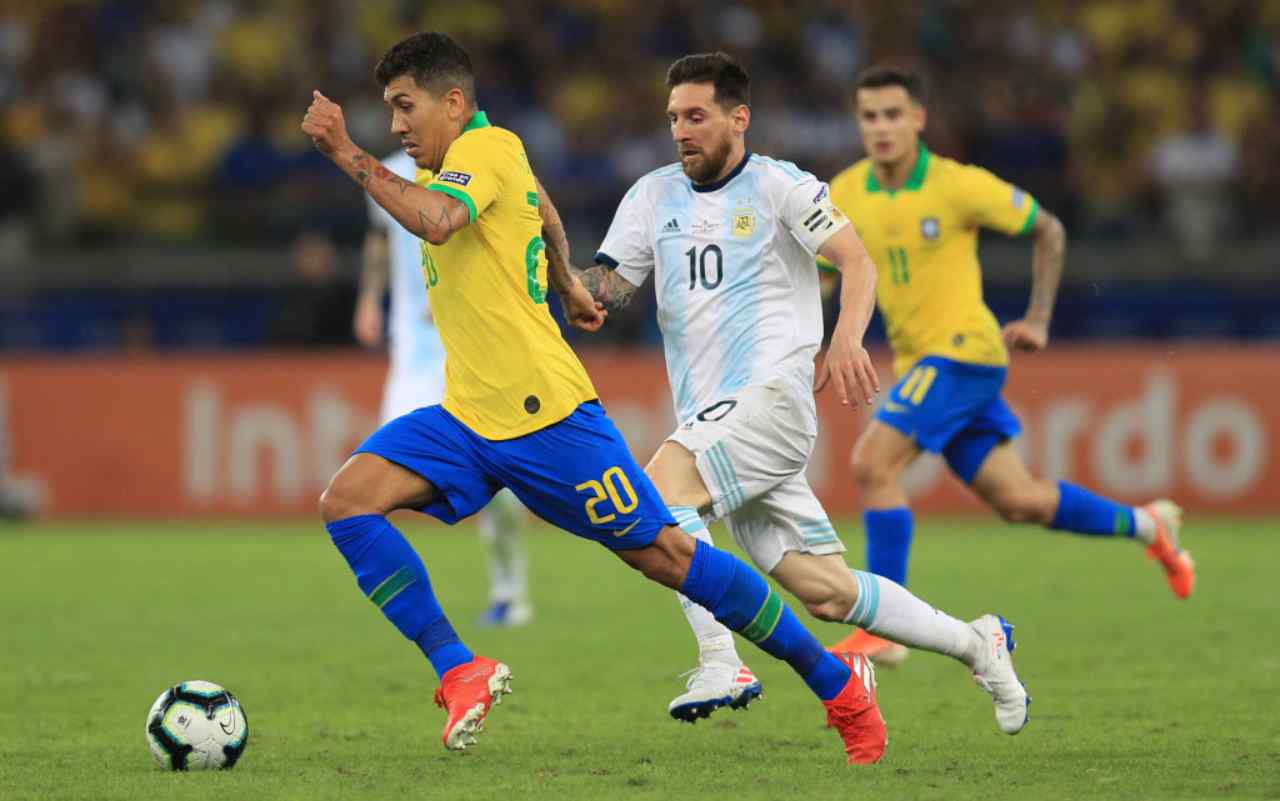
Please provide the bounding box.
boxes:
[814,225,879,406]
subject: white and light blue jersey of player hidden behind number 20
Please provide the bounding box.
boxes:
[369,150,444,371]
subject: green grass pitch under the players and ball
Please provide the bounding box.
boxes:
[0,518,1280,801]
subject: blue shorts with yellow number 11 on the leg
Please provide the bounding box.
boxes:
[876,356,1023,484]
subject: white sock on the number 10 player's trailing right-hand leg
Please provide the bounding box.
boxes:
[845,571,979,668]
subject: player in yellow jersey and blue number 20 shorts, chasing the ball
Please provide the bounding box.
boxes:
[302,33,901,761]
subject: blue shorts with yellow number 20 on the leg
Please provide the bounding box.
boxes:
[356,402,676,550]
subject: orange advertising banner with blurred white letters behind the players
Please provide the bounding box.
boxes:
[0,345,1280,517]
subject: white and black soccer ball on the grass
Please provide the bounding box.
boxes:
[146,681,248,770]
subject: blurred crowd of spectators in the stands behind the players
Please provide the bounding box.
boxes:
[0,0,1280,349]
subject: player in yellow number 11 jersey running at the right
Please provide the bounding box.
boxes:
[831,67,1196,663]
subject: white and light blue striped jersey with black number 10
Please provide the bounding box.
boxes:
[596,154,849,422]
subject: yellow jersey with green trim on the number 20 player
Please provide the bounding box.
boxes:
[416,111,596,440]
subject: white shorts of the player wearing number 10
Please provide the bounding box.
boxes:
[667,377,845,573]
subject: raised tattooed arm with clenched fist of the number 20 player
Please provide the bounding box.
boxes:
[302,91,471,244]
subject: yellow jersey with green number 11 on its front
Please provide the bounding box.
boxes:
[831,145,1039,376]
